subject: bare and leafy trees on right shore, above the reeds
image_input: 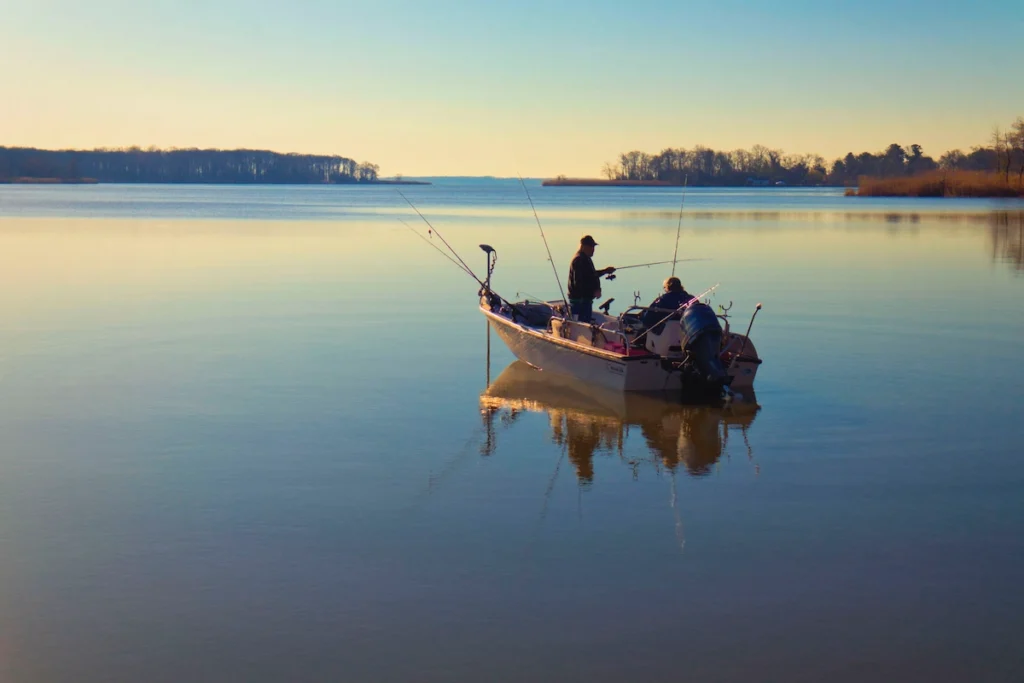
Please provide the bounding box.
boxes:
[602,117,1024,185]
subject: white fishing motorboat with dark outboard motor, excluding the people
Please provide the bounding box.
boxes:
[478,245,762,399]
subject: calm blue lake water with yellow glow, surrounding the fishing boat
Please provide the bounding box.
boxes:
[0,181,1024,683]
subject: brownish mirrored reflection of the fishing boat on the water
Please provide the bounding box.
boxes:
[480,360,760,485]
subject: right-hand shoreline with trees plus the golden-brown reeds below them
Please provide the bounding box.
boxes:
[544,117,1024,197]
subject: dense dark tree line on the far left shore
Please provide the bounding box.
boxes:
[0,146,379,183]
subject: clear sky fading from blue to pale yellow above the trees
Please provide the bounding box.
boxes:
[0,0,1024,177]
